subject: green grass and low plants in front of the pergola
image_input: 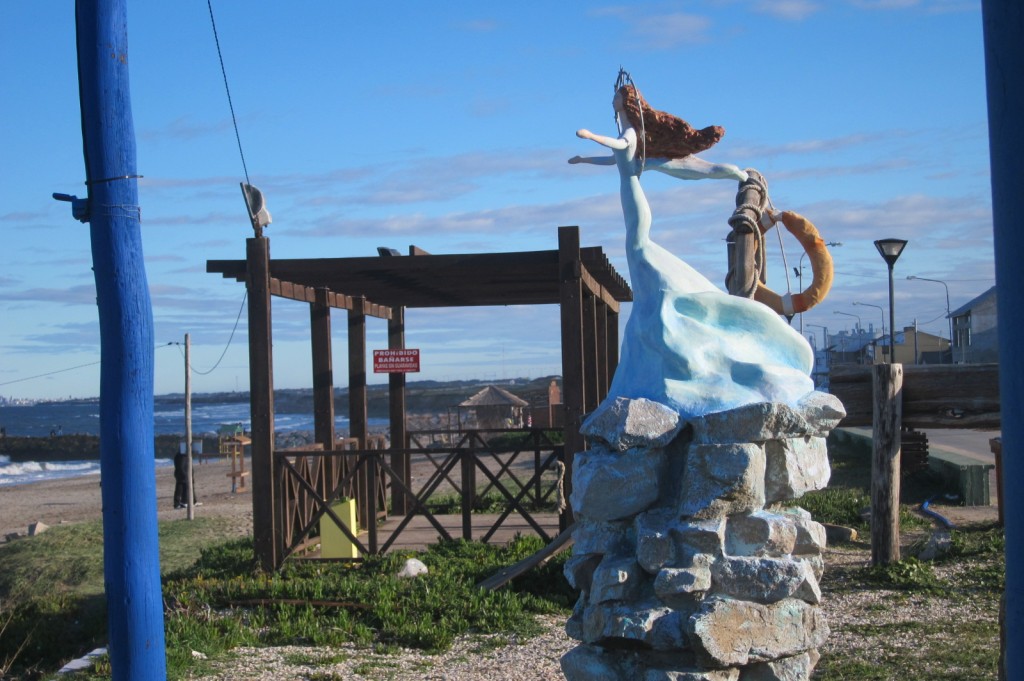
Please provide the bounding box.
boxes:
[0,520,577,681]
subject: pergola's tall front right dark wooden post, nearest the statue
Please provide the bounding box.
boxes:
[558,227,586,529]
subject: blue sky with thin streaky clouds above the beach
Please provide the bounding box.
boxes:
[0,0,994,398]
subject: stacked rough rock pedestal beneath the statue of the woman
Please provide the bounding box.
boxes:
[561,392,845,681]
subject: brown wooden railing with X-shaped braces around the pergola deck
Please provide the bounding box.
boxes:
[274,429,564,557]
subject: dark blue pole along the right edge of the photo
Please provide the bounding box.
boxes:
[981,0,1024,679]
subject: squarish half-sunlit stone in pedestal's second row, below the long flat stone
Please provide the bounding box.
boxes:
[679,442,765,519]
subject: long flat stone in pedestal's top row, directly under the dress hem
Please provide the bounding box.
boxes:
[688,402,811,444]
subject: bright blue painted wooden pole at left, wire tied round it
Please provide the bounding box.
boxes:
[75,0,167,681]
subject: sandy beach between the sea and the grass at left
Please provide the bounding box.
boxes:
[0,457,252,541]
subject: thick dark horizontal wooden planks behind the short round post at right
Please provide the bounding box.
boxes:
[829,364,1001,429]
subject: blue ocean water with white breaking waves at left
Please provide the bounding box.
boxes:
[0,398,387,486]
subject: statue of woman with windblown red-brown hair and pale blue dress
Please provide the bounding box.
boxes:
[569,84,814,418]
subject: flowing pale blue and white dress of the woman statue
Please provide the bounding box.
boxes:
[608,127,814,418]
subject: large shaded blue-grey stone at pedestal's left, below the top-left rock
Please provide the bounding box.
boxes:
[569,448,665,520]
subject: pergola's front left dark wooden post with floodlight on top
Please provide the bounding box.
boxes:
[246,237,284,570]
